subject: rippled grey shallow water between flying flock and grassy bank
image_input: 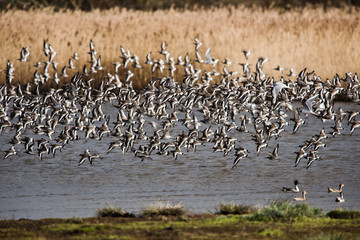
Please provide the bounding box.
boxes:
[0,103,360,219]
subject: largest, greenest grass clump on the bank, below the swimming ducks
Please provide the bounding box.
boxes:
[249,201,323,222]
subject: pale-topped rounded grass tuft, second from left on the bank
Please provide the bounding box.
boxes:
[141,201,186,217]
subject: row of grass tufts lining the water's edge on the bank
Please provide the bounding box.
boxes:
[96,200,360,222]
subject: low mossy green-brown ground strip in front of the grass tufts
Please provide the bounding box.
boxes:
[0,211,360,239]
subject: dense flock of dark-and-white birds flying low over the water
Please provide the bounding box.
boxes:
[0,38,360,204]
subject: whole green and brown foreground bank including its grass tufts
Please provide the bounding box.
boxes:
[0,201,360,239]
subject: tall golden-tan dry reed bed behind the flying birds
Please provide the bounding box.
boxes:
[0,8,360,87]
